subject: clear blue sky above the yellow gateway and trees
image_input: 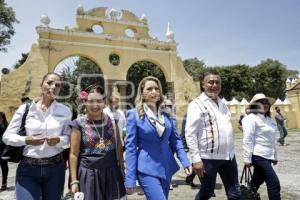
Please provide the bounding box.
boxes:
[0,0,300,71]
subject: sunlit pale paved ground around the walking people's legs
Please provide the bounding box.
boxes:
[0,130,300,200]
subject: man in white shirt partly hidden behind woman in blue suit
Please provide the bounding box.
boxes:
[103,95,126,147]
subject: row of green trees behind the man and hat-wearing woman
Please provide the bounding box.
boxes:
[183,58,290,100]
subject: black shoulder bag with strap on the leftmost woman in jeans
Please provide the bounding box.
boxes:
[1,102,31,163]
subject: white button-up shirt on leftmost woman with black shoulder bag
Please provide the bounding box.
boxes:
[3,101,72,158]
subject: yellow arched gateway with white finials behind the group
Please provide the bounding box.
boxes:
[0,7,199,122]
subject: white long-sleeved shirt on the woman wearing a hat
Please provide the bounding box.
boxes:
[242,113,277,163]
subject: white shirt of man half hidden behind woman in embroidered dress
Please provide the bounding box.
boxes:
[103,106,126,146]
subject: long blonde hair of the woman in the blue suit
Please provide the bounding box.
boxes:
[135,76,164,118]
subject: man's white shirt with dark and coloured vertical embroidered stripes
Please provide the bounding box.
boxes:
[185,92,234,163]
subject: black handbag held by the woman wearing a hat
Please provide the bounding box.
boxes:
[240,166,260,200]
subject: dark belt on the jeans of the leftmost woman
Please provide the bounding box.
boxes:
[21,153,63,165]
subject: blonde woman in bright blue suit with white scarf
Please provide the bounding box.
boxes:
[125,76,192,200]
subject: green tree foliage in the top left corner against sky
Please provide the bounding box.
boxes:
[0,0,19,52]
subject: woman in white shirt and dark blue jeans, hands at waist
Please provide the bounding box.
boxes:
[3,72,72,200]
